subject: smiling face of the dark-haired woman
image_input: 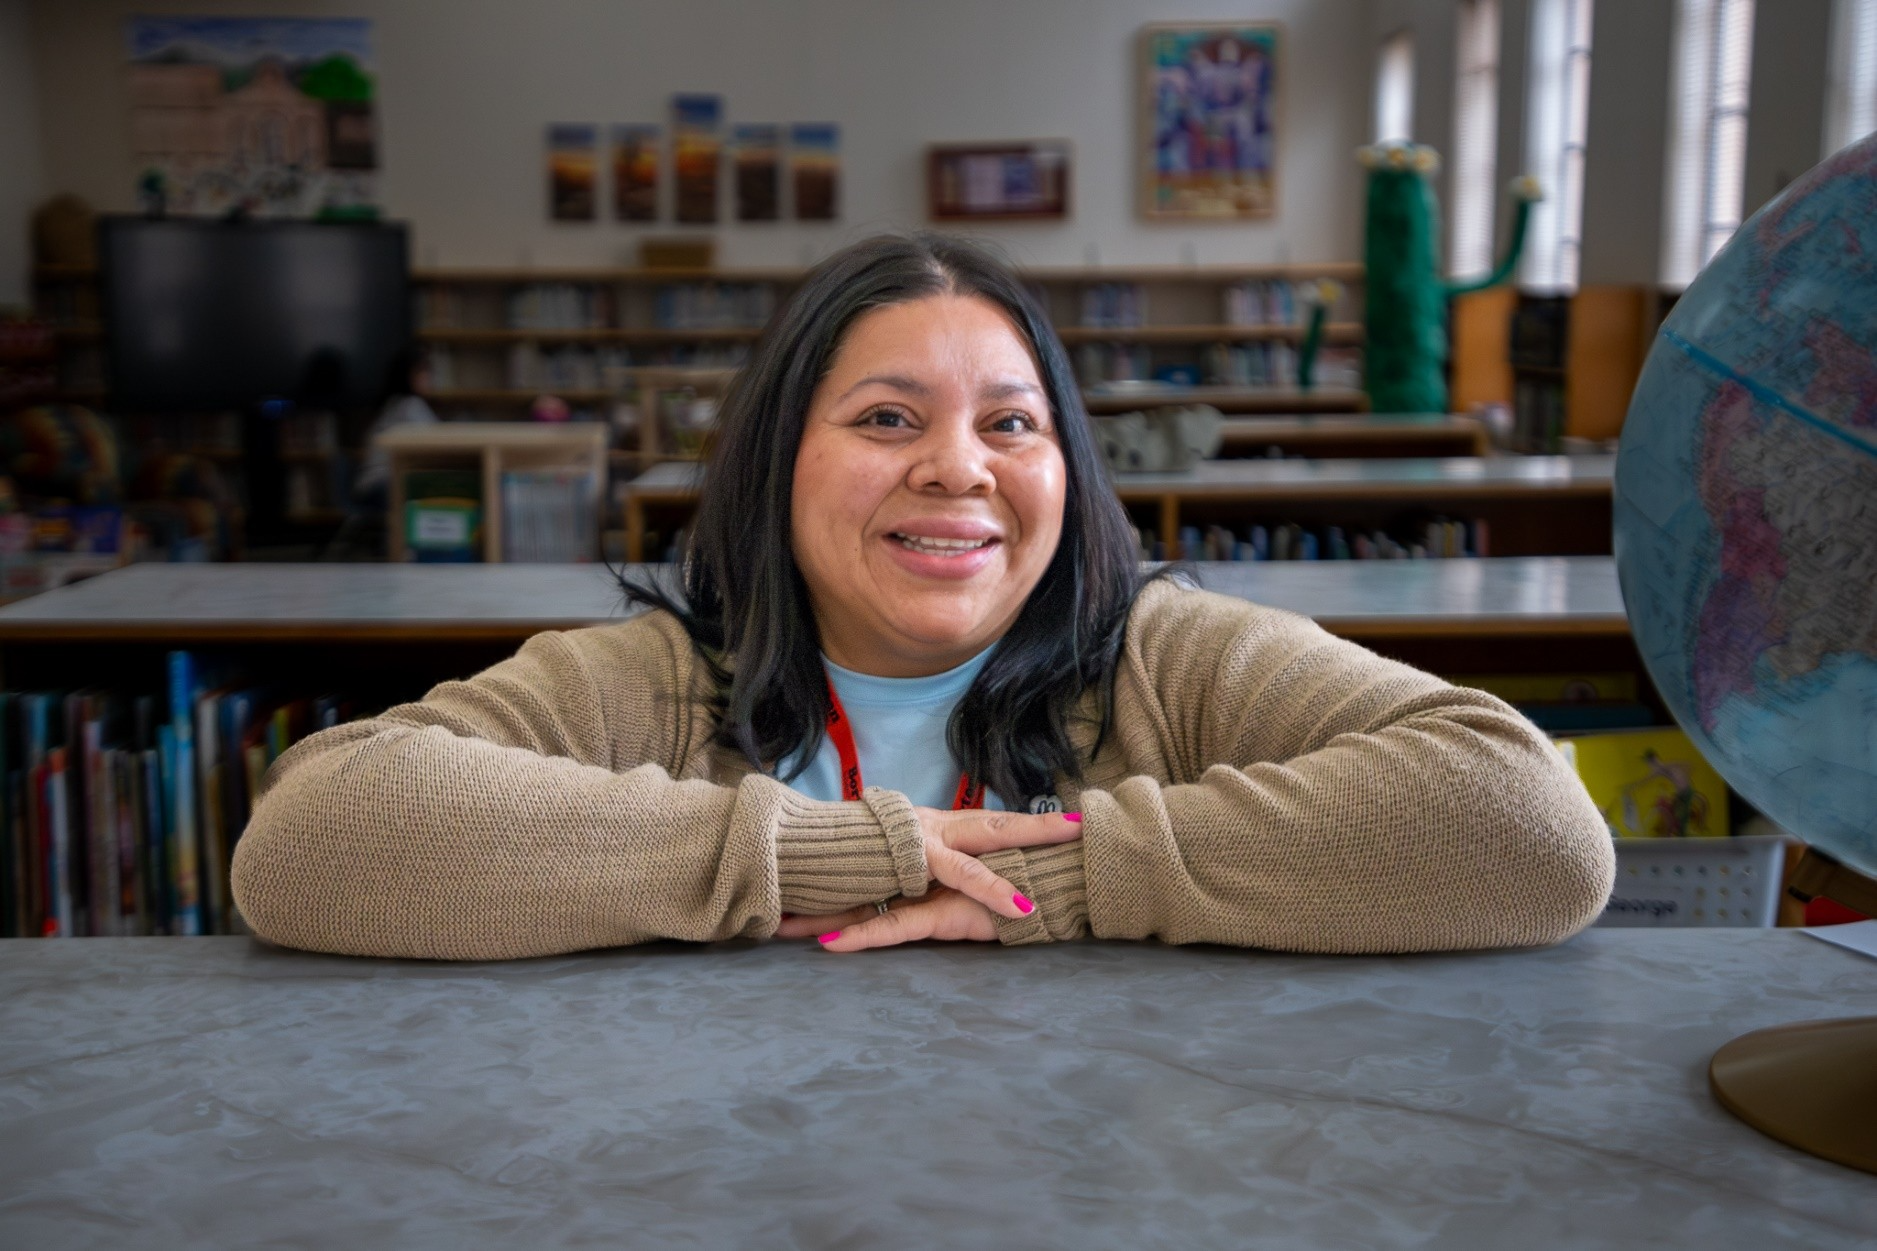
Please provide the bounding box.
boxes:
[790,295,1066,678]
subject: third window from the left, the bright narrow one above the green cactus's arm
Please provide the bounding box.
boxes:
[1522,0,1592,295]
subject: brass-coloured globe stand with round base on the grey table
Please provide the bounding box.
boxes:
[1708,847,1877,1172]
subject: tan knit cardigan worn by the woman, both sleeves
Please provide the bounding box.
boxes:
[235,582,1614,960]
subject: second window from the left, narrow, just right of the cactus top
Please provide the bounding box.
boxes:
[1447,0,1500,278]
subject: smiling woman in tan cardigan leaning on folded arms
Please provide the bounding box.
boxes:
[235,239,1614,958]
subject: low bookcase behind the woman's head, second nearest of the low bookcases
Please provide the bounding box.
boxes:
[619,456,1616,560]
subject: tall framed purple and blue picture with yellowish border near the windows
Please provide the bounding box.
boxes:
[1139,23,1282,222]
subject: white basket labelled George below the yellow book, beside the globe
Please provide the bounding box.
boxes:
[1597,834,1785,928]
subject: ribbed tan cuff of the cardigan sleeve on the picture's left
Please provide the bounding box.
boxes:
[775,791,900,917]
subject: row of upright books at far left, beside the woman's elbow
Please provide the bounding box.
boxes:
[0,652,351,937]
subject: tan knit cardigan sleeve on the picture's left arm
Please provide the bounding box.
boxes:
[233,612,925,960]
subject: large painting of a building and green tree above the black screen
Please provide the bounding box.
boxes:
[126,17,377,218]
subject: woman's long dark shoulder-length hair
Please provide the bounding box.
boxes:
[619,235,1141,806]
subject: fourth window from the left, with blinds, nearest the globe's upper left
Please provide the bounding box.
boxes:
[1661,0,1753,289]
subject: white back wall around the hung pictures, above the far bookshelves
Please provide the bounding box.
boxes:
[32,0,1372,265]
